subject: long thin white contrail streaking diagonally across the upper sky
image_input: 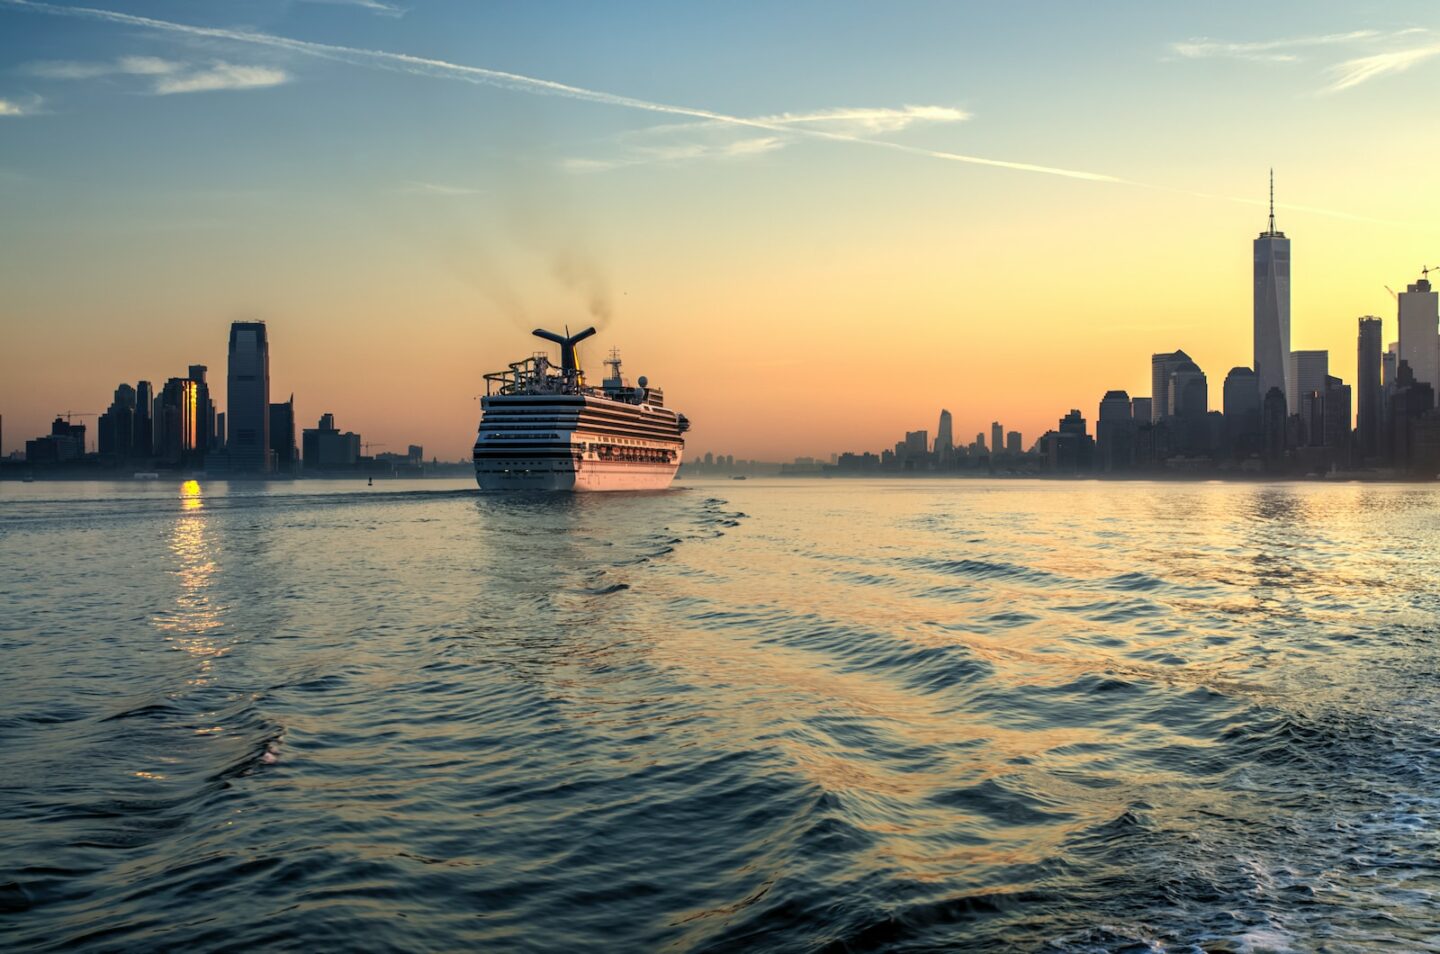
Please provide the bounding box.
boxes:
[0,0,1125,183]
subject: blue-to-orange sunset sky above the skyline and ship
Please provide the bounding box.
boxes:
[0,0,1440,460]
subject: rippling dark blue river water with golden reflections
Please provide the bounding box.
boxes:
[0,480,1440,951]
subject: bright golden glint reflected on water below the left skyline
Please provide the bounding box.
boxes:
[154,480,229,686]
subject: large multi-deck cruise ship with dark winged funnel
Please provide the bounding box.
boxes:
[474,329,690,490]
